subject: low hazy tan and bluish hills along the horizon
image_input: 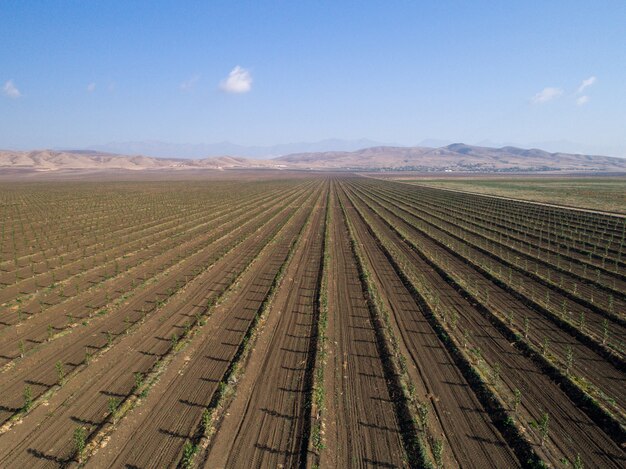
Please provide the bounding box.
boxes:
[0,143,626,173]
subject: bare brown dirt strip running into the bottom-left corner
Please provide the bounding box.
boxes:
[0,182,310,465]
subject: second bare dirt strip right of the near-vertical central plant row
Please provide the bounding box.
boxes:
[338,183,519,468]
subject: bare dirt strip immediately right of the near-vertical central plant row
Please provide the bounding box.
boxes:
[320,183,408,467]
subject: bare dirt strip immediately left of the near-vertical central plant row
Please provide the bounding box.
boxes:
[205,181,327,468]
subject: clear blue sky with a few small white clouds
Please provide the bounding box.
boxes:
[0,0,626,156]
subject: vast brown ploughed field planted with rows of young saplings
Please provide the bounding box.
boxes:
[0,171,626,469]
